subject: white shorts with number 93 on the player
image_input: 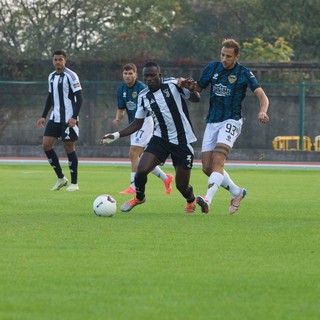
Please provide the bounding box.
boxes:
[201,119,243,152]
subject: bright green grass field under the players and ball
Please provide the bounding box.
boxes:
[0,164,320,320]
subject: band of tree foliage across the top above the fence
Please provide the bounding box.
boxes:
[0,0,320,76]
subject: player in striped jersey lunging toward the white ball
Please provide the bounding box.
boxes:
[101,62,200,214]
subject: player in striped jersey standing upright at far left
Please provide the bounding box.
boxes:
[37,51,82,191]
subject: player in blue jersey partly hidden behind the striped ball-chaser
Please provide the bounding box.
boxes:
[112,63,173,194]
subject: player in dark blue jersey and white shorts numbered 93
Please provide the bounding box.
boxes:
[179,39,269,214]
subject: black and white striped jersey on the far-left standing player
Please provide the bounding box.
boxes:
[48,68,82,123]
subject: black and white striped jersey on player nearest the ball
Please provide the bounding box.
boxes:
[135,78,197,145]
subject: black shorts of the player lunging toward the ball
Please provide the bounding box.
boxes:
[145,136,194,169]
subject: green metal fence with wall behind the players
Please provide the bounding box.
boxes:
[0,81,320,149]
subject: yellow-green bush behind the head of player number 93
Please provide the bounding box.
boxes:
[241,38,293,62]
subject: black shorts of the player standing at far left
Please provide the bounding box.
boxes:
[44,120,79,141]
